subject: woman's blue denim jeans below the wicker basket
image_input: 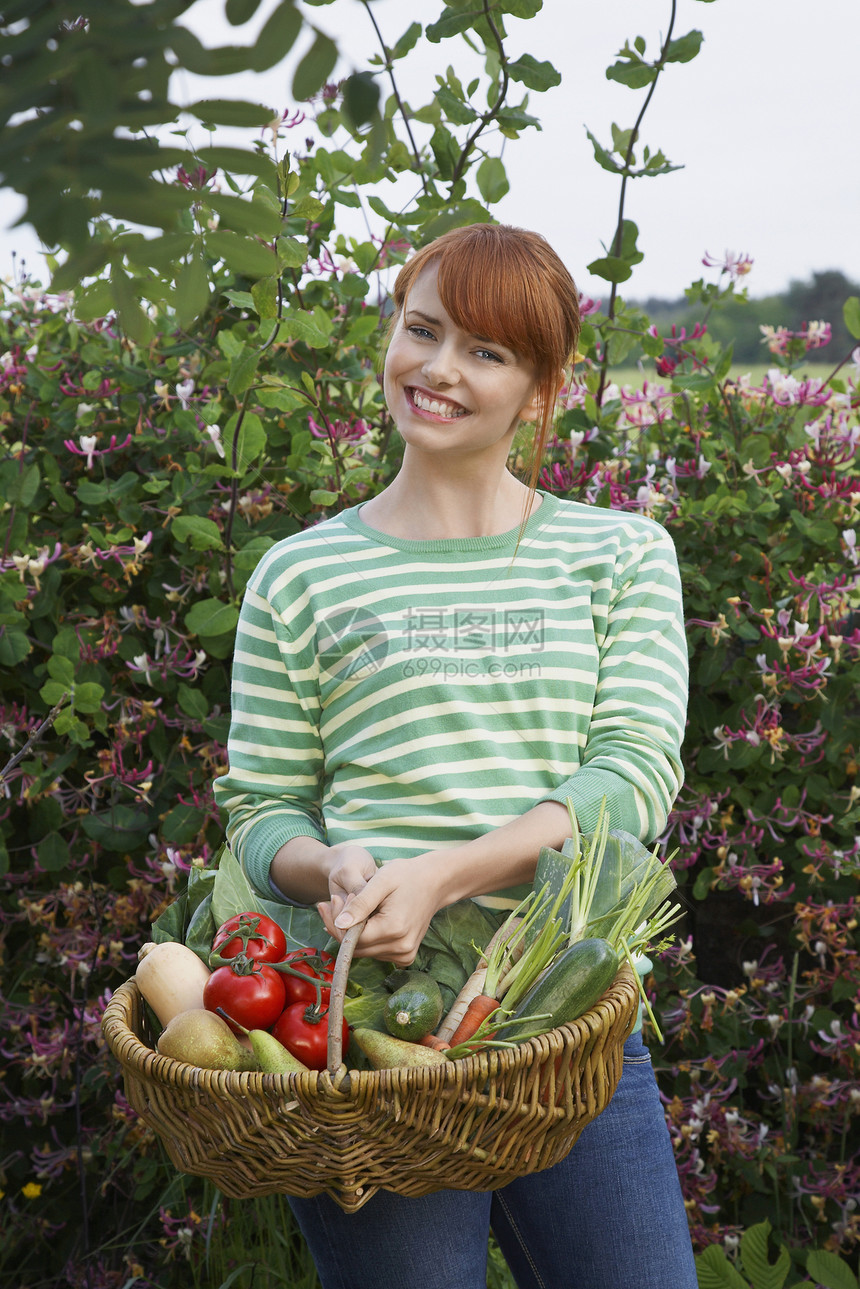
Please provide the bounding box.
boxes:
[290,1034,696,1289]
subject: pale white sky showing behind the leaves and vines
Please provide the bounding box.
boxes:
[0,0,860,299]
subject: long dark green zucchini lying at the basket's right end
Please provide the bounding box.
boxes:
[502,938,620,1043]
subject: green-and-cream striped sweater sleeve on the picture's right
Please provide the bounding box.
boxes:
[545,532,687,843]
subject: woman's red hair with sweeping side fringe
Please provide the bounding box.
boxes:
[393,224,580,491]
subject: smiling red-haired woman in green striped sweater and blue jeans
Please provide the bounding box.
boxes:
[217,224,696,1289]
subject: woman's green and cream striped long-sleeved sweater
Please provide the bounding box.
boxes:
[215,492,687,909]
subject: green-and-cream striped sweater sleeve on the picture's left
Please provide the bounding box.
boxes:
[214,569,325,902]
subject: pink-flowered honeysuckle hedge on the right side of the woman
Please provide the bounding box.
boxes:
[564,274,860,1283]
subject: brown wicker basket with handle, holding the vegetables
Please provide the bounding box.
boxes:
[103,922,638,1213]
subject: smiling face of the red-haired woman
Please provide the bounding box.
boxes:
[383,264,538,460]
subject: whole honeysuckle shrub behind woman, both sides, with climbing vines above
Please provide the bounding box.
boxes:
[0,0,860,1289]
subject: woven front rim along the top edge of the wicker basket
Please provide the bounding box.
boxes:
[102,963,638,1097]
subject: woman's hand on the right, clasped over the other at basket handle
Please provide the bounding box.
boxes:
[318,855,441,967]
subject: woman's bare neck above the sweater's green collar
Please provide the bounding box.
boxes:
[361,451,540,541]
